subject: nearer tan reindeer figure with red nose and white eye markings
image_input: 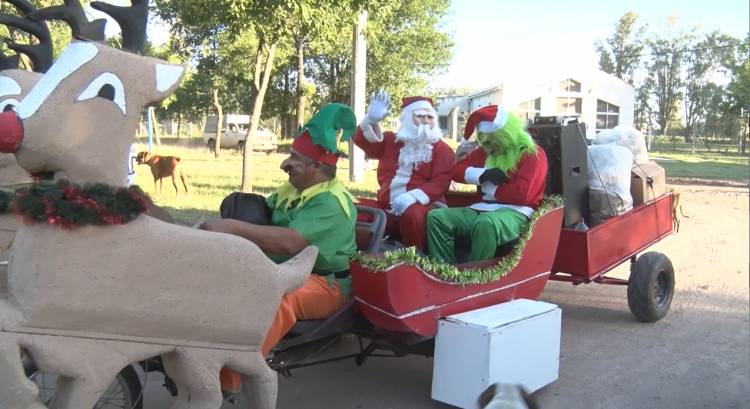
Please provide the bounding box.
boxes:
[0,0,317,409]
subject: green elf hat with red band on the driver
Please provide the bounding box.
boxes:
[292,103,357,166]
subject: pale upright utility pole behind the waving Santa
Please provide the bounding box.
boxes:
[349,10,367,182]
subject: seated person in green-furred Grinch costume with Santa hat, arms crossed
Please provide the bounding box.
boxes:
[427,105,547,263]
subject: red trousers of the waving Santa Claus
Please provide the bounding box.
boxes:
[357,199,432,253]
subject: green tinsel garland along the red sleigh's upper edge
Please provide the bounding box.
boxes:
[354,195,564,284]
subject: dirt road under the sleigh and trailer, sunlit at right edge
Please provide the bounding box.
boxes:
[146,185,750,409]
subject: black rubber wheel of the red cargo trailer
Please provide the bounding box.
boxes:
[628,251,674,322]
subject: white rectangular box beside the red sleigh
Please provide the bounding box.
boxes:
[432,299,561,409]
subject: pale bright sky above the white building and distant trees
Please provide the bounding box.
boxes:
[430,0,750,89]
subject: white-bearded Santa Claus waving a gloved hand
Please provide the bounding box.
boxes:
[354,91,455,251]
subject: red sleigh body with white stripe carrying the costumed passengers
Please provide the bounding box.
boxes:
[351,193,563,337]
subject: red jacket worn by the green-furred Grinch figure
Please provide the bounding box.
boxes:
[451,145,547,209]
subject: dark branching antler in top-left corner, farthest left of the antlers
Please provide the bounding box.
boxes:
[0,0,52,72]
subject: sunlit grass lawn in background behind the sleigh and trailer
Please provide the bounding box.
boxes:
[136,138,749,224]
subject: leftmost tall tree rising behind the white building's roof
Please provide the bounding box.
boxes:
[594,11,646,85]
